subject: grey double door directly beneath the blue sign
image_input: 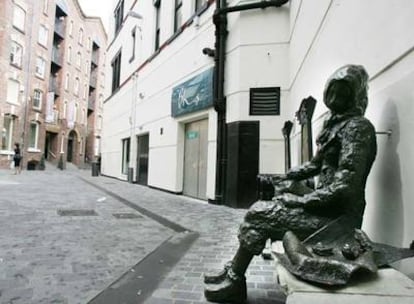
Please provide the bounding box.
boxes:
[183,119,208,200]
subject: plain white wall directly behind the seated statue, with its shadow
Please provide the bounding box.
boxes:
[289,0,414,276]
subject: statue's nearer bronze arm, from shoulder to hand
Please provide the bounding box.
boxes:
[302,120,376,209]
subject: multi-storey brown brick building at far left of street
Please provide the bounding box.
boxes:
[0,0,106,169]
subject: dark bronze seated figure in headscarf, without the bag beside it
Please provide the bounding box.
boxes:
[204,65,377,303]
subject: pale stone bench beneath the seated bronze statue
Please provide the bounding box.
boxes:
[275,257,414,304]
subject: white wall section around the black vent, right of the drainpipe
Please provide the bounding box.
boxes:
[225,1,290,173]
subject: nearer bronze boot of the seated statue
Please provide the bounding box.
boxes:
[204,268,247,304]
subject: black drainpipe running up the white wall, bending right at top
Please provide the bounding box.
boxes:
[213,0,289,204]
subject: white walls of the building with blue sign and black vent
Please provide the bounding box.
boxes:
[102,1,289,199]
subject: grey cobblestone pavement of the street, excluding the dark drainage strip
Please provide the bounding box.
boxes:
[0,169,284,304]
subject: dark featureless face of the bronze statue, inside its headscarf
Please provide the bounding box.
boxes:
[325,80,354,114]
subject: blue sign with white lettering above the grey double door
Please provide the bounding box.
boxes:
[171,68,213,117]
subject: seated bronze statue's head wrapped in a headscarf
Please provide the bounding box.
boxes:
[323,64,368,115]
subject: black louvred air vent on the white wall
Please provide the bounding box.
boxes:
[250,87,280,115]
